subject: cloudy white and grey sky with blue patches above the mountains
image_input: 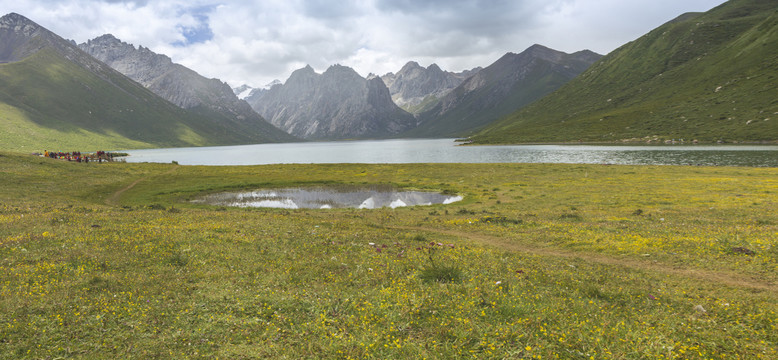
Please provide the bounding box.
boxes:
[0,0,724,87]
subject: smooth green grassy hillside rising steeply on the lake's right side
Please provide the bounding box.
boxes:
[473,0,778,143]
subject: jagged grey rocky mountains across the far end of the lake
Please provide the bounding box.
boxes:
[247,45,600,140]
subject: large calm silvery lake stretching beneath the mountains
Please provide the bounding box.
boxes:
[124,139,778,167]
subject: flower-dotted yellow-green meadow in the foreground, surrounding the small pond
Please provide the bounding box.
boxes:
[0,153,778,359]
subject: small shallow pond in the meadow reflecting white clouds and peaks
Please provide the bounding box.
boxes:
[193,187,462,209]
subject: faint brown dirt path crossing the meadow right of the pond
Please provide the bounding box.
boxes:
[391,226,778,297]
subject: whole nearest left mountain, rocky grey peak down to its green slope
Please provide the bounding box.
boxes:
[0,13,292,150]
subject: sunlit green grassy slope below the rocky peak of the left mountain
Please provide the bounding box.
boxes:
[0,49,292,151]
